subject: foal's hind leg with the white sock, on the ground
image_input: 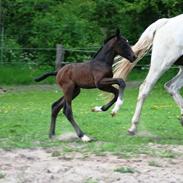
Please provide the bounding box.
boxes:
[63,86,91,142]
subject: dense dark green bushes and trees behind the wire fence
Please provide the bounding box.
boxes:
[2,0,183,64]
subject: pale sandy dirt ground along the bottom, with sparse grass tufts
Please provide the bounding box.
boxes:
[0,146,183,183]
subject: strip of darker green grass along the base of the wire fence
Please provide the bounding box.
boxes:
[0,63,177,86]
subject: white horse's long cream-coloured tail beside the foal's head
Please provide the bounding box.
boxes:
[114,18,168,80]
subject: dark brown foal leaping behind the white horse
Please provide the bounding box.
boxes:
[36,31,136,141]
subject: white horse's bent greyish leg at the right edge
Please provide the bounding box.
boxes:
[164,66,183,126]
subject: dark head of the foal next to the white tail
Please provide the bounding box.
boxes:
[113,29,137,62]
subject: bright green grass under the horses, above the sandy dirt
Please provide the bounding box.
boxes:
[0,85,183,156]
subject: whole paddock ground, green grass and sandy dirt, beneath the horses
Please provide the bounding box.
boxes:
[0,81,183,183]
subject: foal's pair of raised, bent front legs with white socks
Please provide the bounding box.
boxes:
[92,78,126,116]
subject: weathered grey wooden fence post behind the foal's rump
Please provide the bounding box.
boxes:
[55,44,64,70]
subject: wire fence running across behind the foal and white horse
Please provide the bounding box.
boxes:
[0,34,178,70]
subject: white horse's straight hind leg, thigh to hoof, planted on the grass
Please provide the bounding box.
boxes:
[128,22,182,134]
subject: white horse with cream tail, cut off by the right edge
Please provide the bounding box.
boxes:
[113,14,183,135]
